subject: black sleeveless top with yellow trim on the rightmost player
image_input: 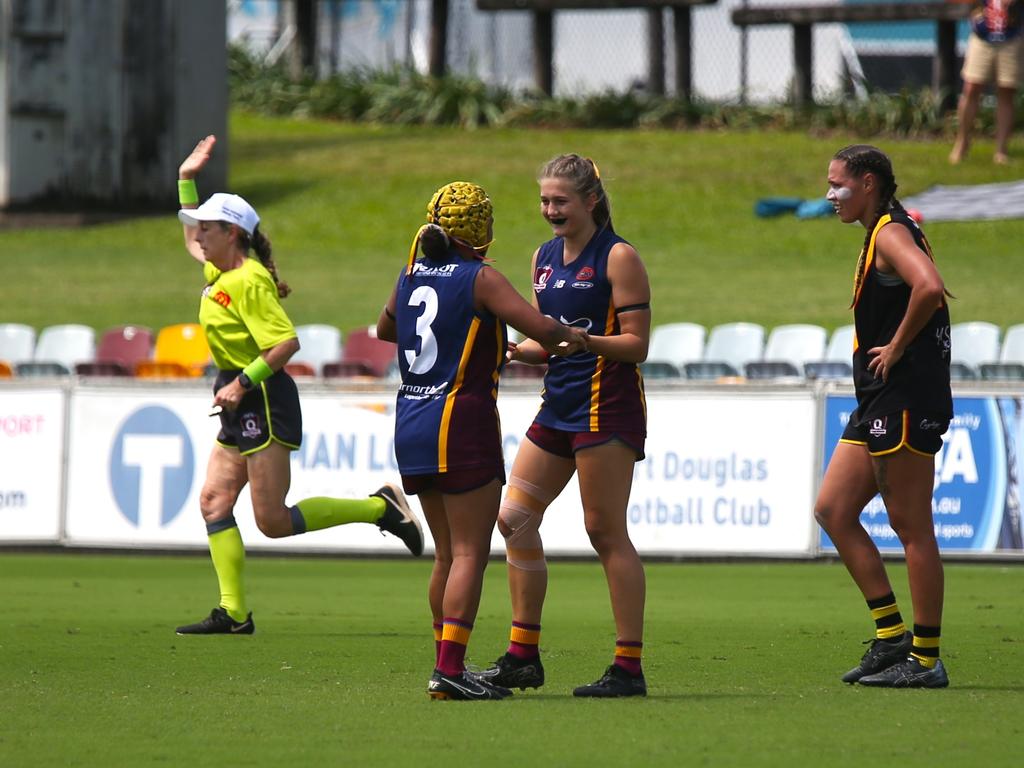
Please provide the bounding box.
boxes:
[852,209,953,425]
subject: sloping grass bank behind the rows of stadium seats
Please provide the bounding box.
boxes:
[0,113,1024,330]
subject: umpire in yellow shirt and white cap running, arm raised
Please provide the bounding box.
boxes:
[177,136,423,635]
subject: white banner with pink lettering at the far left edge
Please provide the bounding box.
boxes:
[0,387,65,544]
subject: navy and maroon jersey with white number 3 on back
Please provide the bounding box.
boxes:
[394,251,507,475]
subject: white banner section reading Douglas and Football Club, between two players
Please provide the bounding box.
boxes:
[602,392,816,556]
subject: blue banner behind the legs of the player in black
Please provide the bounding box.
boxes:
[820,395,1024,552]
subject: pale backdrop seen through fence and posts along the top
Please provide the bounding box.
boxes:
[228,0,967,104]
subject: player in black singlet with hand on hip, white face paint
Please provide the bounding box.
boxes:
[814,144,952,688]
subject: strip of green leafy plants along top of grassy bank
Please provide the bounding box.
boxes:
[228,46,1015,137]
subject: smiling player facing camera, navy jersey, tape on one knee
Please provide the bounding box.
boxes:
[481,155,650,697]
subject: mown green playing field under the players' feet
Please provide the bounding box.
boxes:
[0,553,1024,768]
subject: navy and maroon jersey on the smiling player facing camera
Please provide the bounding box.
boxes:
[534,227,647,434]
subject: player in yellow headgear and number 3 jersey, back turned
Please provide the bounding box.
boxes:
[377,181,587,700]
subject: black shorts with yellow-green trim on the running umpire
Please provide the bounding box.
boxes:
[213,371,302,456]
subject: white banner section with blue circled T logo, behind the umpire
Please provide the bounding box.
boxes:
[67,387,411,552]
